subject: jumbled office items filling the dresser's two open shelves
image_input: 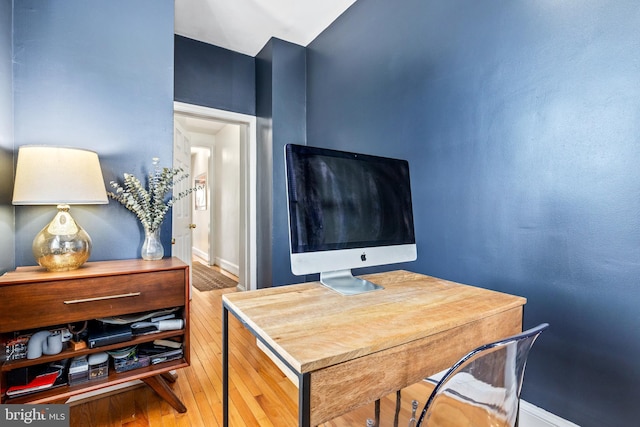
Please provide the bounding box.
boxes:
[0,307,184,398]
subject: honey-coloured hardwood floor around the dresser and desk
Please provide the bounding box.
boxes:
[70,289,428,427]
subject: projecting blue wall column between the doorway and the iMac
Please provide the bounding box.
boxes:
[256,38,307,287]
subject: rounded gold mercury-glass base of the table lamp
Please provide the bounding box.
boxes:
[31,205,91,271]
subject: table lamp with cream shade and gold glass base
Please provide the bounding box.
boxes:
[13,145,109,271]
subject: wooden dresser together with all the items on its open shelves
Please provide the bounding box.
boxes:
[0,258,190,412]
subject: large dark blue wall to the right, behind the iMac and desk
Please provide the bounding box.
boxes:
[307,0,640,427]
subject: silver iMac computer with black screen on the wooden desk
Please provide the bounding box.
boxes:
[285,144,417,295]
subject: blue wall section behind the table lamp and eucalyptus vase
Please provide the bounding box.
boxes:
[13,0,174,265]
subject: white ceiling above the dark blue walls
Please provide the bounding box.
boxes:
[174,0,355,56]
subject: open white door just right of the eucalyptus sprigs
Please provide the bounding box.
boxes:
[171,120,193,292]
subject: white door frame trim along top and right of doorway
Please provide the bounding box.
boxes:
[173,101,257,290]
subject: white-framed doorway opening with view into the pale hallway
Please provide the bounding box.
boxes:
[172,102,257,290]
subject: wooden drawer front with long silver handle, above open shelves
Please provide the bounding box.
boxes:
[0,270,186,332]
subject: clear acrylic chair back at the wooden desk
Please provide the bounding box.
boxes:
[417,323,549,427]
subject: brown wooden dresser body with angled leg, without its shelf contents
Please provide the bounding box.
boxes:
[0,258,189,412]
